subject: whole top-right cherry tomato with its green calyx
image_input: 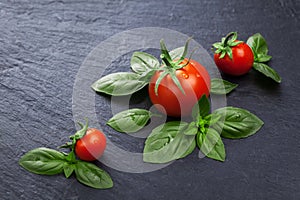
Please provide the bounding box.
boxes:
[213,32,254,76]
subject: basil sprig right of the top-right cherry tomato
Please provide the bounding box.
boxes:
[247,33,281,83]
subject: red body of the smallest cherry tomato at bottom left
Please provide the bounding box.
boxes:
[75,128,106,161]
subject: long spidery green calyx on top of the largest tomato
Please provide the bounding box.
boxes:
[154,37,196,96]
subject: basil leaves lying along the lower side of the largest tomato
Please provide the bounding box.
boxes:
[107,95,264,163]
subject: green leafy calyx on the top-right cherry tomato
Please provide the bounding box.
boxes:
[212,32,242,59]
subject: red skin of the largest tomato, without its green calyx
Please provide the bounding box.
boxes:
[148,59,210,117]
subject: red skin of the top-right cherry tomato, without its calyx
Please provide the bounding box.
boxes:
[214,42,254,76]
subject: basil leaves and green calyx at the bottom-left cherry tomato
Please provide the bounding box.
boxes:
[19,121,113,189]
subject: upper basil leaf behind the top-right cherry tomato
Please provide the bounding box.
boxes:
[247,33,268,55]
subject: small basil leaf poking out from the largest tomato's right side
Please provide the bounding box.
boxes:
[210,78,238,94]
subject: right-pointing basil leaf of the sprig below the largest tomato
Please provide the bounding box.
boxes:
[213,107,264,139]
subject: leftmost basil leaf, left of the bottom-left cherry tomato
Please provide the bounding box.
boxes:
[19,148,66,175]
